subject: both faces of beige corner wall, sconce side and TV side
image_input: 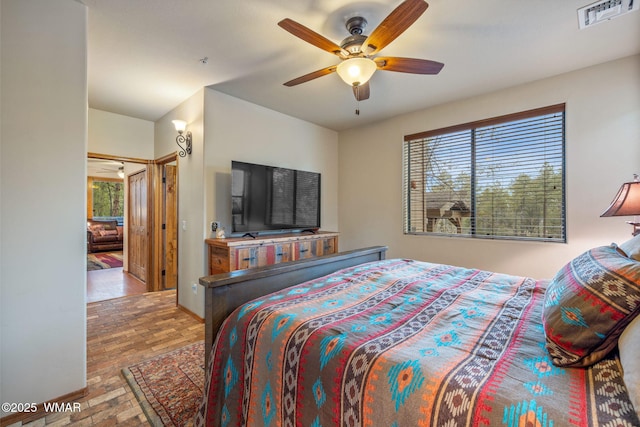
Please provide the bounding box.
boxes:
[155,88,338,317]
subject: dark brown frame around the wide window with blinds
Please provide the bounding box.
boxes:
[402,103,567,243]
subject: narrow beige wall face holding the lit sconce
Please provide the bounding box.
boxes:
[155,90,205,318]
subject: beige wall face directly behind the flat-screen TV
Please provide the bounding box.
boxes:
[204,89,339,239]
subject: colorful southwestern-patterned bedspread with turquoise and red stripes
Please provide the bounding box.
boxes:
[196,260,638,427]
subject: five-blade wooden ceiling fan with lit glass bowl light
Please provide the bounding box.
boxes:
[278,0,444,101]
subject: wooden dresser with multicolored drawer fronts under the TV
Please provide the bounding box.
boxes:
[205,231,338,274]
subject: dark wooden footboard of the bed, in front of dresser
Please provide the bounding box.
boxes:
[200,246,387,366]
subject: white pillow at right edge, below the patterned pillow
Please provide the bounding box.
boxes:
[618,316,640,419]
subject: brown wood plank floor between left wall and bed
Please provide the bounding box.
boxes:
[13,290,204,427]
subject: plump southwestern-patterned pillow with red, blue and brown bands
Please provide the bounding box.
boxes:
[542,245,640,367]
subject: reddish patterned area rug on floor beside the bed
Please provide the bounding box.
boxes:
[122,341,204,427]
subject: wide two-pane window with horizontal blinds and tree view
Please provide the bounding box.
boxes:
[403,104,566,242]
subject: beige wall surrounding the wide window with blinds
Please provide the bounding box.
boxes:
[339,56,640,278]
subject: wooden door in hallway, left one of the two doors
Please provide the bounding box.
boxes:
[127,169,149,283]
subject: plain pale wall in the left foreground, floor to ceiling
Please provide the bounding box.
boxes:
[0,0,87,416]
